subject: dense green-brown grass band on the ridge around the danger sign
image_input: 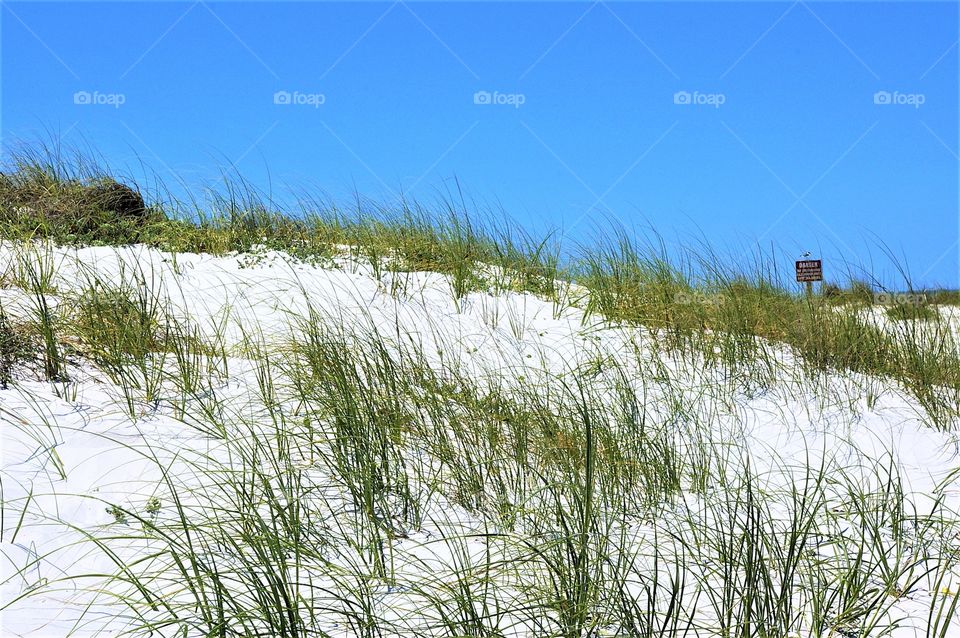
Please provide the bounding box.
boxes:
[578,237,960,421]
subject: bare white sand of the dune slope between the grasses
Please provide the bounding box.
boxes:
[0,247,960,636]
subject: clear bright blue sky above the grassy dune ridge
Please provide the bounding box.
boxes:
[0,2,960,286]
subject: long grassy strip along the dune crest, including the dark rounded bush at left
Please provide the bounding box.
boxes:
[0,147,561,296]
